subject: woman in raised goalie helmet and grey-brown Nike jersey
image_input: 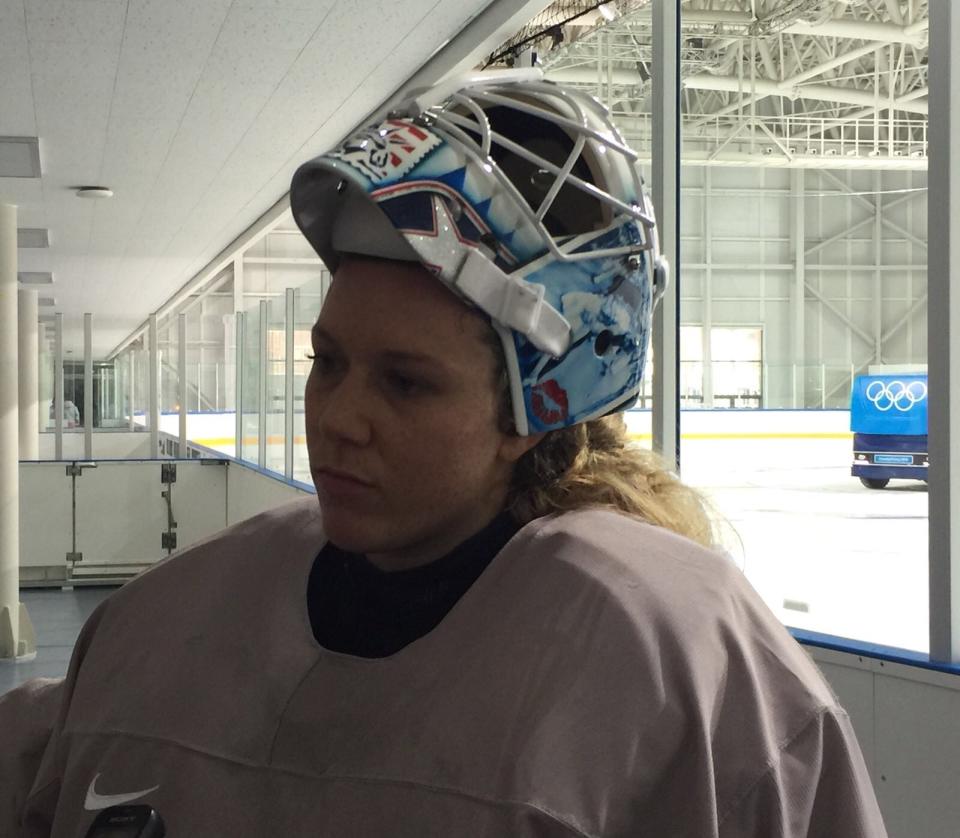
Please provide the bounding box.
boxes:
[0,69,885,838]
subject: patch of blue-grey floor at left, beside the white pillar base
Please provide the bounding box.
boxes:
[0,587,116,695]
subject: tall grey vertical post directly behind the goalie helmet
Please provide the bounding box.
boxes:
[652,2,680,471]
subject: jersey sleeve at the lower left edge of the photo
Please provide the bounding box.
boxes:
[0,678,64,835]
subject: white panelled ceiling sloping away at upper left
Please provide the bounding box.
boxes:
[0,0,516,357]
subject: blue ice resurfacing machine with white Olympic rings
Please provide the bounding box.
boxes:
[850,373,927,489]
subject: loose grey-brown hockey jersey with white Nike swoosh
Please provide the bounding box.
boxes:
[0,498,886,838]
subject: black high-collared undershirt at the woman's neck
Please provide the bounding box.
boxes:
[307,512,519,658]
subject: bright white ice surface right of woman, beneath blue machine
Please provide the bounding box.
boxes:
[668,414,929,652]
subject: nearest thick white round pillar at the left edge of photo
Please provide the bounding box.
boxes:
[0,204,37,659]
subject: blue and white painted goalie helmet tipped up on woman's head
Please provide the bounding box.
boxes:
[290,70,666,435]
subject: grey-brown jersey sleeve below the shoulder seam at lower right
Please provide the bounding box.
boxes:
[719,707,887,838]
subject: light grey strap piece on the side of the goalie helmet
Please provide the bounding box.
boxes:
[452,247,573,358]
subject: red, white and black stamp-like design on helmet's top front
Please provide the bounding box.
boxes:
[330,119,441,183]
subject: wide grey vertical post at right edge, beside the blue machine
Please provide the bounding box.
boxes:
[927,0,960,663]
